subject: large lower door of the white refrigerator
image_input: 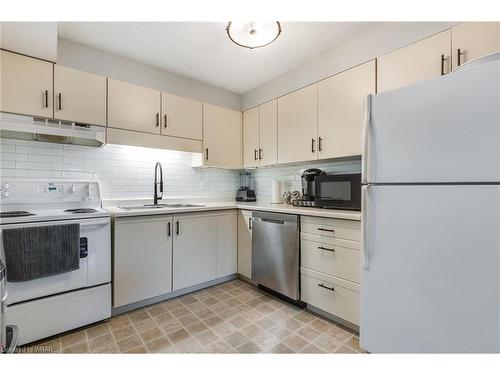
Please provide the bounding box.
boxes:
[360,185,500,353]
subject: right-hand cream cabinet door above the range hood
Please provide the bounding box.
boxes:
[54,64,106,126]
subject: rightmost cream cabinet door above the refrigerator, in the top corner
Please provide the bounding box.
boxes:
[451,22,500,69]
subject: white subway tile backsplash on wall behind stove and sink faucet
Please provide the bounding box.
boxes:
[0,138,239,199]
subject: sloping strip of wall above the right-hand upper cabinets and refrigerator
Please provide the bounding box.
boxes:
[241,22,456,110]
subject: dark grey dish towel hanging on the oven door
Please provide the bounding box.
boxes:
[2,224,80,282]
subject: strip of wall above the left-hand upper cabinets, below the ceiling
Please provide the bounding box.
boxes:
[57,38,240,110]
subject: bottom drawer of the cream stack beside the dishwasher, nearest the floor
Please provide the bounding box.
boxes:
[301,268,359,325]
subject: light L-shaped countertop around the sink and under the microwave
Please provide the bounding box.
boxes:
[104,200,361,221]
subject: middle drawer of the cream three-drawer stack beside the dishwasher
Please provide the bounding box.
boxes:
[301,234,360,283]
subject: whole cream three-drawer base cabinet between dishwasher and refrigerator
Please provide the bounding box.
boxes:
[300,216,361,325]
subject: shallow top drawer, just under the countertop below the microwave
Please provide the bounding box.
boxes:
[300,216,361,241]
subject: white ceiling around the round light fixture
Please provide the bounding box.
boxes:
[58,22,374,94]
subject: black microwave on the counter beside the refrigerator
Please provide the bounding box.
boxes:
[314,173,361,211]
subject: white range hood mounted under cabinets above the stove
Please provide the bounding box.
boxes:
[0,113,106,147]
